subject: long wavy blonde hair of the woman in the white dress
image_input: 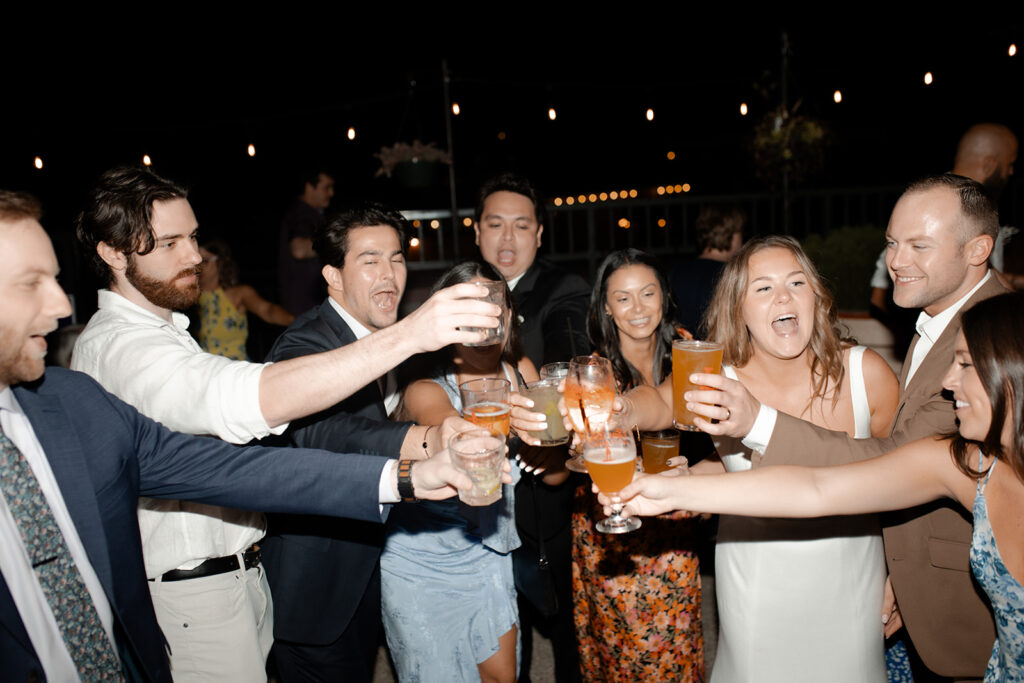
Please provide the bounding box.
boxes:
[705,236,846,407]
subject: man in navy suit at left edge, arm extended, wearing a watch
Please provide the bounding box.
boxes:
[0,190,479,681]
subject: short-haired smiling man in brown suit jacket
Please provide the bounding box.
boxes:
[687,174,1006,679]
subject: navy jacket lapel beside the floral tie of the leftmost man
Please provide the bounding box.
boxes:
[14,380,115,604]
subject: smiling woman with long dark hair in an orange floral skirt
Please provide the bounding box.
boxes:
[572,249,703,681]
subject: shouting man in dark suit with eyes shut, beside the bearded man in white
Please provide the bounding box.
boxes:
[263,205,472,682]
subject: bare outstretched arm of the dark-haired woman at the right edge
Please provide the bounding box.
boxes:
[602,437,974,517]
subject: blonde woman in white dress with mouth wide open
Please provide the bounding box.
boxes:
[624,237,899,683]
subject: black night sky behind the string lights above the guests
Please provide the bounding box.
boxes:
[0,18,1024,307]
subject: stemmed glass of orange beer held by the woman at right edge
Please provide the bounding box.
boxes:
[583,431,640,533]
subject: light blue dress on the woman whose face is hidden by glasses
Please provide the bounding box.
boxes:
[381,367,519,683]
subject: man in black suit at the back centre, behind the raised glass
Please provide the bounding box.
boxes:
[473,174,590,681]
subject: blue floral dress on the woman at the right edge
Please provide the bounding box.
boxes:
[971,455,1024,683]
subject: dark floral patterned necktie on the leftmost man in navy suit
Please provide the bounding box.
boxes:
[0,427,124,681]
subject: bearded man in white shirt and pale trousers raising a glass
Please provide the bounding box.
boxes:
[72,168,500,681]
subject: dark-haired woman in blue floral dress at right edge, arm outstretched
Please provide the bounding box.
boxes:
[621,293,1024,683]
